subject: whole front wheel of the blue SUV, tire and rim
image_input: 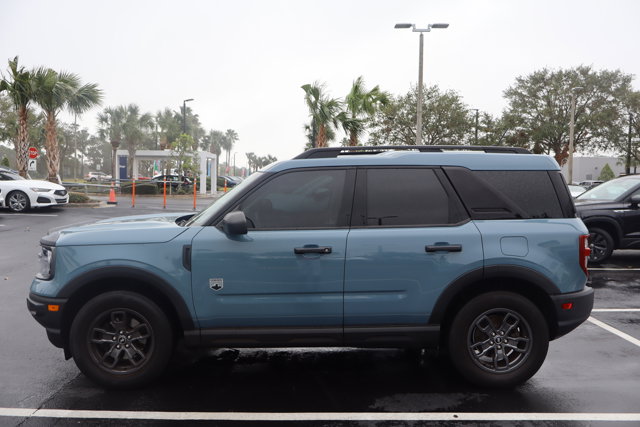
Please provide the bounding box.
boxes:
[69,291,173,388]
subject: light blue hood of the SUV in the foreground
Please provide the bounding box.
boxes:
[42,212,193,246]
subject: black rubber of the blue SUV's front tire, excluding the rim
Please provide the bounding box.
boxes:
[69,291,173,388]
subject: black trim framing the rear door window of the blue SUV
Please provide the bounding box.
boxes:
[351,165,471,230]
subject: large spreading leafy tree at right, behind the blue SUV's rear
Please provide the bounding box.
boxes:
[504,66,632,164]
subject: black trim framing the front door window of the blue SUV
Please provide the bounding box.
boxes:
[215,166,356,233]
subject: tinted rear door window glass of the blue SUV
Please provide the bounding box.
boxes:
[365,169,460,226]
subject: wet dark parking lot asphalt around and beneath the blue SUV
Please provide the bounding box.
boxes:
[0,206,640,426]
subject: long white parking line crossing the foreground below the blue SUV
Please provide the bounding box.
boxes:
[0,408,640,422]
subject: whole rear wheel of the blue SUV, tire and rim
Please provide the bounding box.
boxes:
[448,292,549,388]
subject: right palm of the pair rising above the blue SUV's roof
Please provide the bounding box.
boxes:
[338,76,389,146]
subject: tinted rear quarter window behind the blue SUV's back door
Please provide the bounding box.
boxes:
[475,171,563,218]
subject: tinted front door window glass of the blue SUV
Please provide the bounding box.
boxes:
[239,170,348,229]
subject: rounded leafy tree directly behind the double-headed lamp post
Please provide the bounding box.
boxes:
[369,86,472,145]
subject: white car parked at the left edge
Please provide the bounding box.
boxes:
[0,169,69,212]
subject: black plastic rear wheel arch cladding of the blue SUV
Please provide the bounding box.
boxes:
[429,265,560,339]
